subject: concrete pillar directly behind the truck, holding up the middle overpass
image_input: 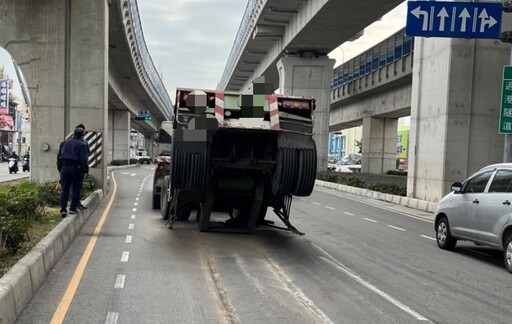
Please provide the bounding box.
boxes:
[277,56,336,171]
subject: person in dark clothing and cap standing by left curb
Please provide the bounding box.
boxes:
[57,128,89,218]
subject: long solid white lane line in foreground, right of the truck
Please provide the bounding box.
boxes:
[312,243,430,321]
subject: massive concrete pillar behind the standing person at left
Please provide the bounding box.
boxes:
[0,0,108,189]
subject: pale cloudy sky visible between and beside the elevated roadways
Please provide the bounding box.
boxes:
[0,0,406,101]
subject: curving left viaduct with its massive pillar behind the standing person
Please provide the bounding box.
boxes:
[0,0,172,189]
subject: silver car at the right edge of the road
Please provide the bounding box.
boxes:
[434,163,512,273]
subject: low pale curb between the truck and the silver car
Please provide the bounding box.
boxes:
[315,180,437,213]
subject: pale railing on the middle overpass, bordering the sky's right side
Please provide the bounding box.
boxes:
[217,0,257,90]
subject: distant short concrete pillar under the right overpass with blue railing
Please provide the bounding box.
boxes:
[361,117,398,174]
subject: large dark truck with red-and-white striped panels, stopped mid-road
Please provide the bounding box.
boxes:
[160,83,317,234]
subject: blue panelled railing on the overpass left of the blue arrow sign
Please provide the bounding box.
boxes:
[331,28,414,90]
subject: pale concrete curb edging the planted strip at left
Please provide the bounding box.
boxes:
[0,165,134,323]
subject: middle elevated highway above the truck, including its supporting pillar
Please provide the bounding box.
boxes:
[218,0,402,170]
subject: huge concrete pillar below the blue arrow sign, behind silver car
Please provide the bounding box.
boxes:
[407,38,510,201]
